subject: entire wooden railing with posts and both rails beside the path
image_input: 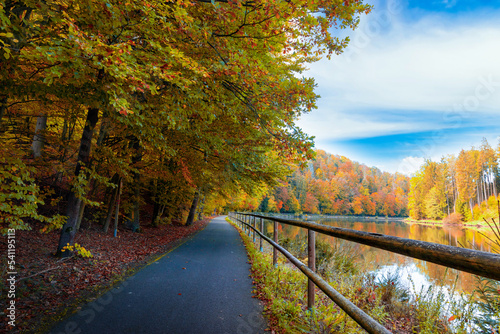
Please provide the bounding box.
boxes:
[229,212,500,333]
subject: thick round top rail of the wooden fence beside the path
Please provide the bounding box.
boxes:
[238,213,500,281]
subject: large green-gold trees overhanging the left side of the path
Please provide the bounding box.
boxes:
[0,0,369,253]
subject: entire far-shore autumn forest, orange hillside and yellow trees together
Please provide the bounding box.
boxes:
[231,140,500,224]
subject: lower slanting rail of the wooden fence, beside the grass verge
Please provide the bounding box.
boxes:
[231,216,391,334]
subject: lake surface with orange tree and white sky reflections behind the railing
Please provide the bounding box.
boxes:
[266,218,493,292]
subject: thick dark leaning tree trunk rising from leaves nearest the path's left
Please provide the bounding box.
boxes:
[56,108,99,257]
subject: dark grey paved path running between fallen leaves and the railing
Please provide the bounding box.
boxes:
[49,217,266,334]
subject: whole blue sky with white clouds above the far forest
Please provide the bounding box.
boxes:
[298,0,500,174]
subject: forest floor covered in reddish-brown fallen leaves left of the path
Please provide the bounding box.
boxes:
[0,218,211,333]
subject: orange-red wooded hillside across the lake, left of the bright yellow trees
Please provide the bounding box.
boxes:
[229,150,410,217]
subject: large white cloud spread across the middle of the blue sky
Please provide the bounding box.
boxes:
[299,4,500,140]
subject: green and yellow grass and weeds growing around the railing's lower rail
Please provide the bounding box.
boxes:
[228,219,474,334]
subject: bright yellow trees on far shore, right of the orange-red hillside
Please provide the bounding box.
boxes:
[408,139,500,222]
